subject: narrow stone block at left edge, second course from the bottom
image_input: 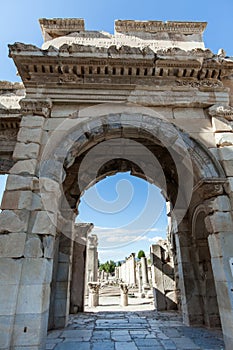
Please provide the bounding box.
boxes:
[0,284,18,316]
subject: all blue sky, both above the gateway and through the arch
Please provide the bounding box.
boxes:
[0,0,233,260]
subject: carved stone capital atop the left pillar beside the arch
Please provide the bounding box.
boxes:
[20,99,52,118]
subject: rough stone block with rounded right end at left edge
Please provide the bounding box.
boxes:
[0,210,26,233]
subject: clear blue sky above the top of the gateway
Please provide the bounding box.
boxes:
[0,0,233,81]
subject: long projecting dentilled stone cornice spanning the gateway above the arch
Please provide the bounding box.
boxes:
[9,43,233,88]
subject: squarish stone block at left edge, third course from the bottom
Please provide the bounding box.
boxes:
[0,258,23,286]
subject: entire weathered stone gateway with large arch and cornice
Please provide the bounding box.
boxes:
[0,19,233,349]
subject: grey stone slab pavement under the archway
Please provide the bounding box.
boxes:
[46,310,224,350]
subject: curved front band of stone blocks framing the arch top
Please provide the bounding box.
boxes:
[40,113,225,223]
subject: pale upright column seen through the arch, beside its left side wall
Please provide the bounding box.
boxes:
[86,234,98,283]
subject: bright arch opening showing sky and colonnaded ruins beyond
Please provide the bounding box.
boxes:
[76,172,168,311]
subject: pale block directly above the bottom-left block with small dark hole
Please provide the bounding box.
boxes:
[16,284,50,314]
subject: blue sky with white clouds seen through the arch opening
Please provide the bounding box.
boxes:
[78,173,167,261]
